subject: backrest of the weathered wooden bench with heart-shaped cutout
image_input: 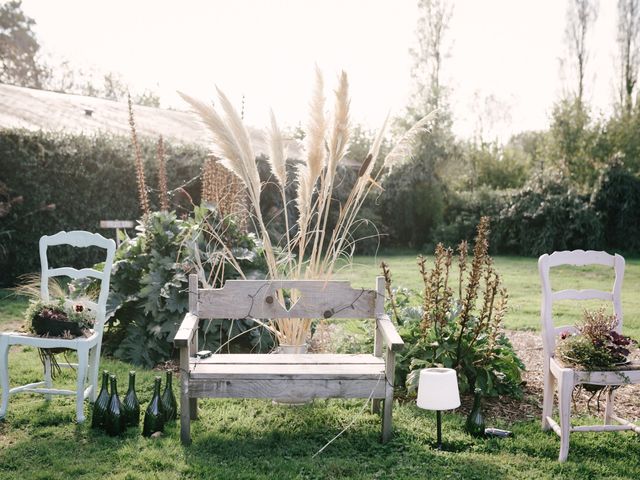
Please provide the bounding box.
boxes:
[189,275,384,319]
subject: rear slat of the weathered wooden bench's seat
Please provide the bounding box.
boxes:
[189,353,384,366]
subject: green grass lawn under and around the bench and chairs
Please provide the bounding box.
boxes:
[0,255,640,480]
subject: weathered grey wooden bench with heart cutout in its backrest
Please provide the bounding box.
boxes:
[174,275,404,444]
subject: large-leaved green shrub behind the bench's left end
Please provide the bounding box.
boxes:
[105,207,270,367]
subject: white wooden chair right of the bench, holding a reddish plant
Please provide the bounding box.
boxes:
[538,250,640,462]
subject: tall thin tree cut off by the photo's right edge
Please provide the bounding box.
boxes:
[617,0,640,115]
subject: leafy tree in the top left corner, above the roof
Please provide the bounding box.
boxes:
[0,0,44,88]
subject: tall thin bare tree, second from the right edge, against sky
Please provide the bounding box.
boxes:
[565,0,598,105]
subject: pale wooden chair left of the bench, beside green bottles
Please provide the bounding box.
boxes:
[0,231,116,423]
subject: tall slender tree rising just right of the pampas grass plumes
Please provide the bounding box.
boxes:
[380,0,457,247]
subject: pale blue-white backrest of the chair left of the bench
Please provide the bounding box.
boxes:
[40,230,116,333]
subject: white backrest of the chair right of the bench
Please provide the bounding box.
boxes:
[538,250,625,356]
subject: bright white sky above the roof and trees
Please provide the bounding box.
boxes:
[18,0,616,139]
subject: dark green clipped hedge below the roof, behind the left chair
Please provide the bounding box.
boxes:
[0,130,207,286]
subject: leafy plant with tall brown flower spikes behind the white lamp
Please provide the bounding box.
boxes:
[385,217,524,396]
